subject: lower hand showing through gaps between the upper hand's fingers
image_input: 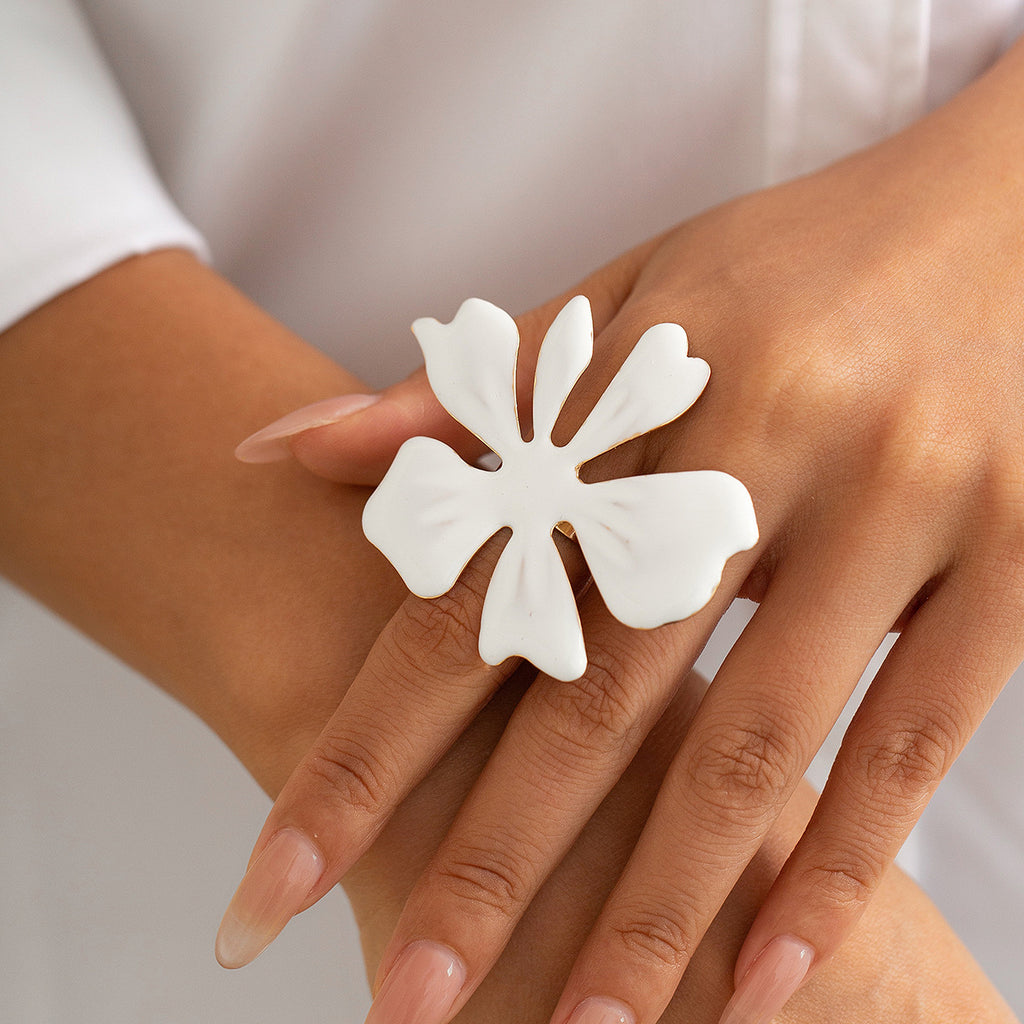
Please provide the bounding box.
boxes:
[352,674,1015,1024]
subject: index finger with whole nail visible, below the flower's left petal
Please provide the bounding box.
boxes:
[217,538,548,967]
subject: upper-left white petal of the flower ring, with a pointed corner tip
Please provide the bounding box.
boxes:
[413,299,521,455]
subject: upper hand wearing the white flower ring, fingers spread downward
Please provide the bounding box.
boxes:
[228,39,1024,1024]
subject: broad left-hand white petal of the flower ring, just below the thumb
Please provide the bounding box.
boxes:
[362,437,502,597]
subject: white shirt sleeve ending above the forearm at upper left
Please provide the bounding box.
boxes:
[0,0,207,330]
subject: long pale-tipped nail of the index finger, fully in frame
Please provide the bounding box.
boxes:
[215,828,324,968]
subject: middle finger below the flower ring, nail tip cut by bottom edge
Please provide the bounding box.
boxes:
[352,548,744,1024]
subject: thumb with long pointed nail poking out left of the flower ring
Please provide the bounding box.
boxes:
[234,368,486,484]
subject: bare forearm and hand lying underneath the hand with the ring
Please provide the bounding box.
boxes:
[0,252,1013,1022]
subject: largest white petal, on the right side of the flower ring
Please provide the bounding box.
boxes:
[571,470,758,629]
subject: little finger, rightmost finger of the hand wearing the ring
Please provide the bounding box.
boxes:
[726,573,1024,1020]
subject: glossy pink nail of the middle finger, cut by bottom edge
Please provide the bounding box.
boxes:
[367,941,466,1024]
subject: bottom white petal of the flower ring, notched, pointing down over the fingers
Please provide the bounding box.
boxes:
[480,530,587,681]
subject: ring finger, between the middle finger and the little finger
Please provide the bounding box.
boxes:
[553,516,937,1024]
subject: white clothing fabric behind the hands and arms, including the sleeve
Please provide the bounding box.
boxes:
[0,0,1024,1024]
